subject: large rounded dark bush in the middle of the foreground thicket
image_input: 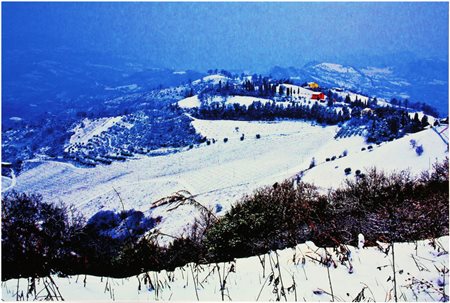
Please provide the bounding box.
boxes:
[205,181,327,260]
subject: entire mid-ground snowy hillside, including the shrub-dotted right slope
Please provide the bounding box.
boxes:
[5,119,448,243]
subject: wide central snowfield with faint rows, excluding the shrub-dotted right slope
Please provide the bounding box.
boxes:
[16,119,337,240]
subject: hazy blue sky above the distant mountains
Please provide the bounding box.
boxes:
[2,2,449,70]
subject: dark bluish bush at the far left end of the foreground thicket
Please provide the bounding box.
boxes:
[2,192,84,280]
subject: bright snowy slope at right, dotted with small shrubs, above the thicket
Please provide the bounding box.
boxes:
[302,129,448,189]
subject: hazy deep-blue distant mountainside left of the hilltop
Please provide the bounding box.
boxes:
[2,49,205,121]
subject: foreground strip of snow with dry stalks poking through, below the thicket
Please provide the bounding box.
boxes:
[2,236,449,302]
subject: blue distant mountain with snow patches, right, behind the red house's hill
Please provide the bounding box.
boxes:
[269,57,448,115]
